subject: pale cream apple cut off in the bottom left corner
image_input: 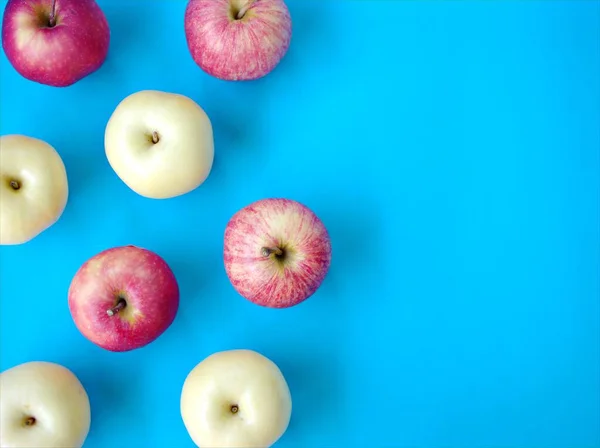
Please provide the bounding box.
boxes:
[0,361,91,448]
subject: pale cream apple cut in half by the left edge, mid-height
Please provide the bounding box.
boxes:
[0,135,69,245]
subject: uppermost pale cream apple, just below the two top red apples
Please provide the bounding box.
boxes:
[104,90,214,199]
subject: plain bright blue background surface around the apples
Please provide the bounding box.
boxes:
[0,0,600,448]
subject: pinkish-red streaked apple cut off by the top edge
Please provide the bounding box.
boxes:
[184,0,292,81]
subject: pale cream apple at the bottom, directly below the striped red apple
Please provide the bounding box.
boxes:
[180,350,292,448]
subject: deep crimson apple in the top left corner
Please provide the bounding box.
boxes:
[2,0,110,87]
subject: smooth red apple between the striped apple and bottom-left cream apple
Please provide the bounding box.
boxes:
[68,246,179,352]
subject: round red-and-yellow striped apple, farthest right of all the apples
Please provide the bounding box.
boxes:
[224,198,331,308]
